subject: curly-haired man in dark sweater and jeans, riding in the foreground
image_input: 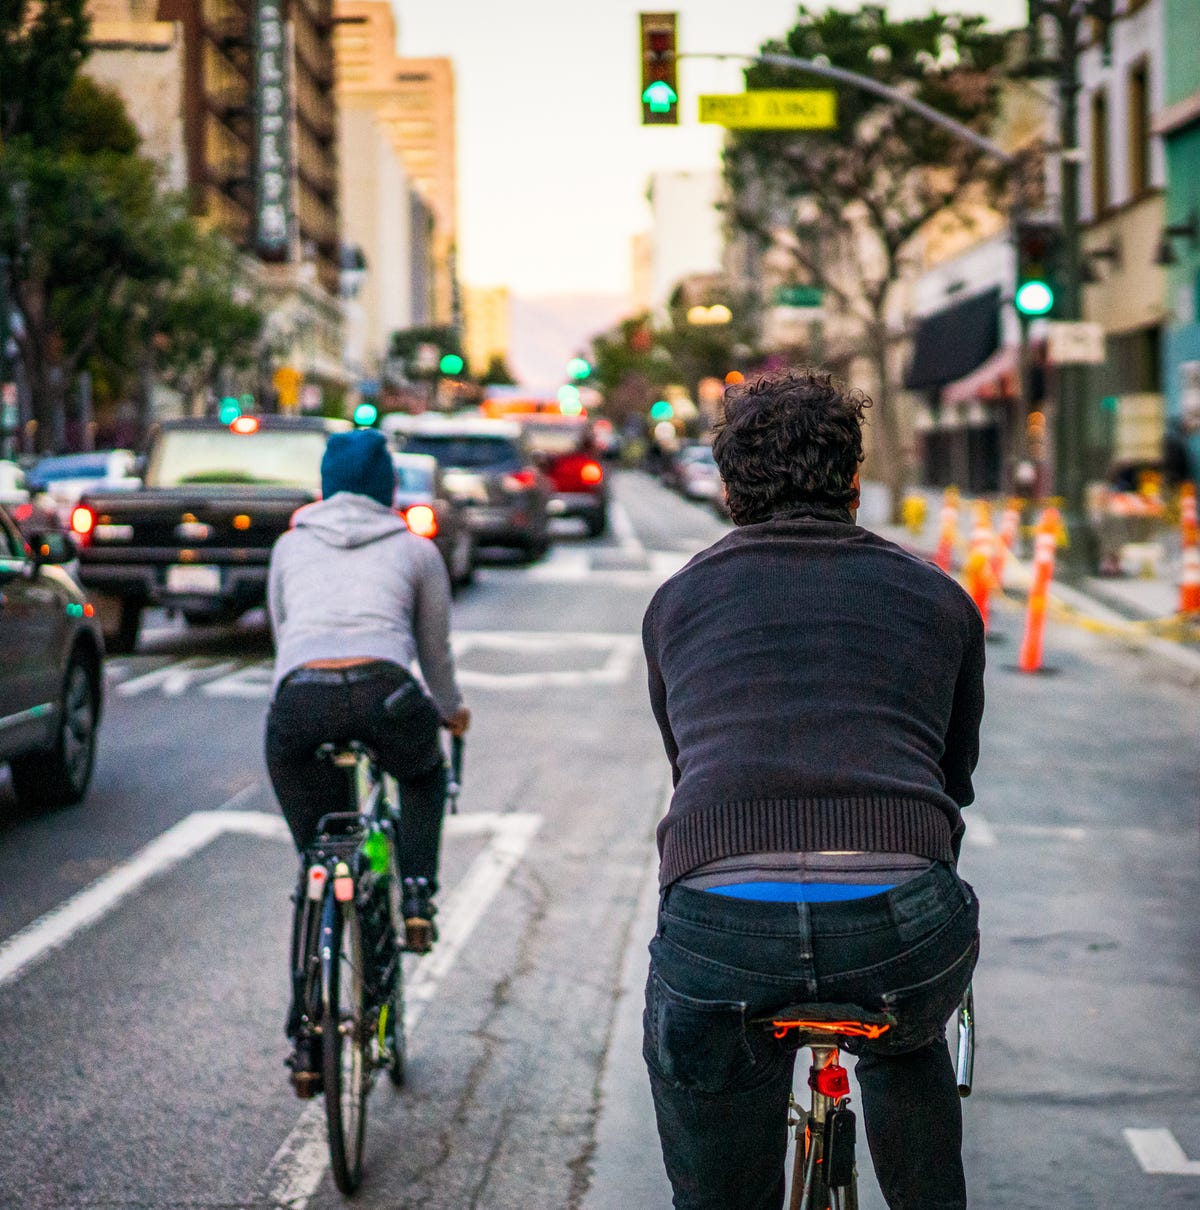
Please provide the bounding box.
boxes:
[644,371,983,1210]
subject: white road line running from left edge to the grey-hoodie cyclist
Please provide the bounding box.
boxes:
[0,785,275,987]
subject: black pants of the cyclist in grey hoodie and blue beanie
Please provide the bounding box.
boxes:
[266,661,445,891]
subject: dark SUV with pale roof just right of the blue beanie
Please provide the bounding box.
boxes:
[381,413,550,560]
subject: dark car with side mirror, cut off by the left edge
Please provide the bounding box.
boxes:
[0,507,104,808]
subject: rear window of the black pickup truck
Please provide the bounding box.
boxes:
[146,428,325,492]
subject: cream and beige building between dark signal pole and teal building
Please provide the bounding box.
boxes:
[1077,0,1166,479]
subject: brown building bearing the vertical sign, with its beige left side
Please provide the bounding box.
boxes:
[86,0,346,409]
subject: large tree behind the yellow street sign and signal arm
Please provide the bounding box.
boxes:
[725,4,1005,502]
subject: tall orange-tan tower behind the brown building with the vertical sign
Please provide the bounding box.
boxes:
[334,0,461,324]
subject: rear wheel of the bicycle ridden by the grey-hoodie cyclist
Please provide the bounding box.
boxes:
[321,891,370,1193]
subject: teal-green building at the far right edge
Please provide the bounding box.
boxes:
[1153,0,1200,479]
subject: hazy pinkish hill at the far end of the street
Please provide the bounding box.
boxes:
[508,294,633,391]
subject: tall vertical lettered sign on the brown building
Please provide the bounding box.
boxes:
[254,0,293,260]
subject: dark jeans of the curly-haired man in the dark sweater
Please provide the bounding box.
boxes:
[642,865,979,1210]
